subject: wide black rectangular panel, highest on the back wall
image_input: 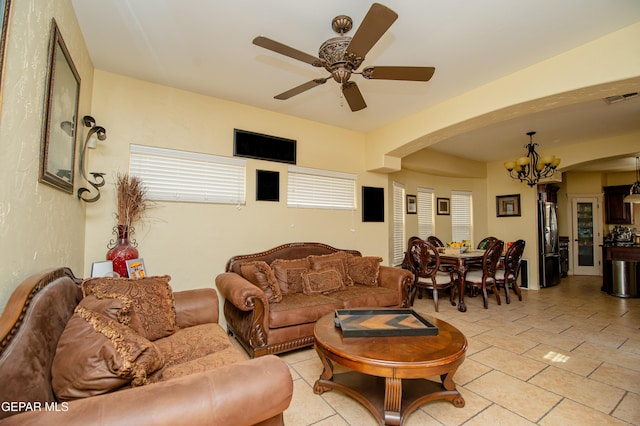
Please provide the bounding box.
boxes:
[233,129,296,164]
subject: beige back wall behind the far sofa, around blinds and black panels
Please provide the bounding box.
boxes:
[84,71,388,289]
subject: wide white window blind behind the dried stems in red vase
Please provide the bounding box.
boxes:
[129,145,246,204]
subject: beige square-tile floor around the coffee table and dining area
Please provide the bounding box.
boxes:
[281,276,640,426]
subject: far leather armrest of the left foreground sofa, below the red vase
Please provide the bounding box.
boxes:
[173,288,220,328]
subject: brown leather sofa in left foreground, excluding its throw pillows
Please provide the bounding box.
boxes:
[0,268,293,426]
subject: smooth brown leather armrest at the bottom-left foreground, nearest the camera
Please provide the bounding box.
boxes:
[0,355,293,426]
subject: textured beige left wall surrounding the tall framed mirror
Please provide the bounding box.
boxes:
[0,0,93,307]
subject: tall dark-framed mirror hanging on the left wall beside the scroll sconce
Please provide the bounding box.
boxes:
[39,19,80,193]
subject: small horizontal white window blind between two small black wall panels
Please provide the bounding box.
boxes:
[287,166,357,210]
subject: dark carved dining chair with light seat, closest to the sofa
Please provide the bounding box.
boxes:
[408,239,456,312]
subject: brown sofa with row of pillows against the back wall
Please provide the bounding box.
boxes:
[216,243,413,357]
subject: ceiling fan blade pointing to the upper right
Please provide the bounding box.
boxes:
[346,3,398,58]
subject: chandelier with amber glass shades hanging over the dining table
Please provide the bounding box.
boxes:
[504,132,560,186]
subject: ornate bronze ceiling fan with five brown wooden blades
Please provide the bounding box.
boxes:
[253,3,435,111]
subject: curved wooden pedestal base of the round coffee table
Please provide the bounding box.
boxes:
[313,371,465,425]
